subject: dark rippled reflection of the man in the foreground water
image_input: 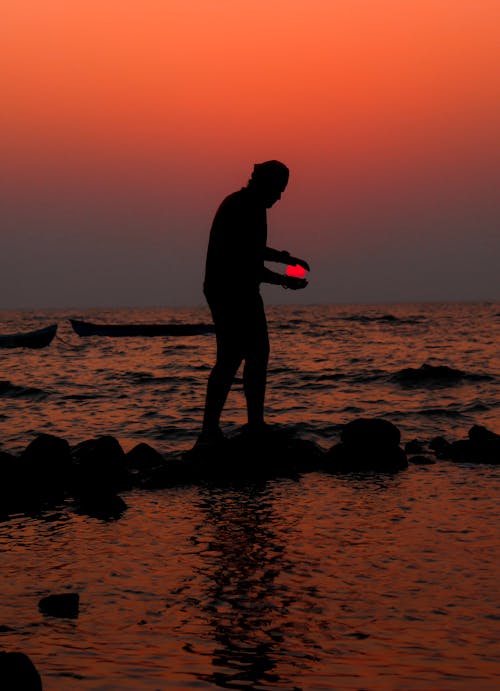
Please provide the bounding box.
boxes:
[195,487,299,689]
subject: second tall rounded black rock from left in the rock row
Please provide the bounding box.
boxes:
[72,436,132,497]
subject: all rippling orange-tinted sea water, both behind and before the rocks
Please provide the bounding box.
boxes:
[0,303,500,691]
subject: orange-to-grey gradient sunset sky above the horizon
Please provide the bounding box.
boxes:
[0,0,500,308]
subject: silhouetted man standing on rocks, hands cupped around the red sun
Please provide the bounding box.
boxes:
[198,161,309,444]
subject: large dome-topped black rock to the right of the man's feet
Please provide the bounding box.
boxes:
[325,418,408,473]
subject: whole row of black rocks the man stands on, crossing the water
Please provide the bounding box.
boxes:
[0,418,500,519]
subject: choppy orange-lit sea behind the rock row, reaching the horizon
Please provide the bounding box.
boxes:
[0,304,500,451]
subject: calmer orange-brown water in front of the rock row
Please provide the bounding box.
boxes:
[0,463,500,691]
